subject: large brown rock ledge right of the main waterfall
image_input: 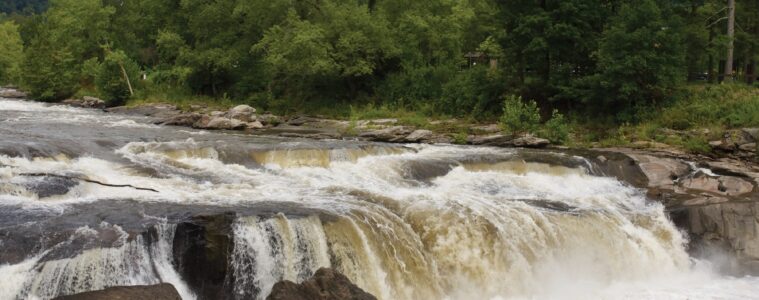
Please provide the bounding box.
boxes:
[596,149,759,274]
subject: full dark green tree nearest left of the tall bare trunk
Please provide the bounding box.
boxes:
[592,0,685,118]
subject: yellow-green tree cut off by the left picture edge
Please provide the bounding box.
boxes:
[0,21,23,84]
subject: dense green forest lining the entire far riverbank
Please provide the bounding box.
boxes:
[0,0,759,122]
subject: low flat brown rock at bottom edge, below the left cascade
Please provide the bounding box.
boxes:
[54,283,182,300]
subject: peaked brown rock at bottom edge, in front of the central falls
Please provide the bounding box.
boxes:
[266,268,377,300]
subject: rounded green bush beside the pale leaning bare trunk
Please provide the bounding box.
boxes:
[95,50,140,106]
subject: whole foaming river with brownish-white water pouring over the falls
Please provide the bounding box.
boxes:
[0,99,759,299]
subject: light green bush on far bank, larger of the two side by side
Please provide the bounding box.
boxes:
[501,95,540,134]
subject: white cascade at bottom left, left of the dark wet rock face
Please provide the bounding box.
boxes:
[0,224,195,299]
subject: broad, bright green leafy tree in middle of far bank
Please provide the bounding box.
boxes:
[252,1,398,102]
